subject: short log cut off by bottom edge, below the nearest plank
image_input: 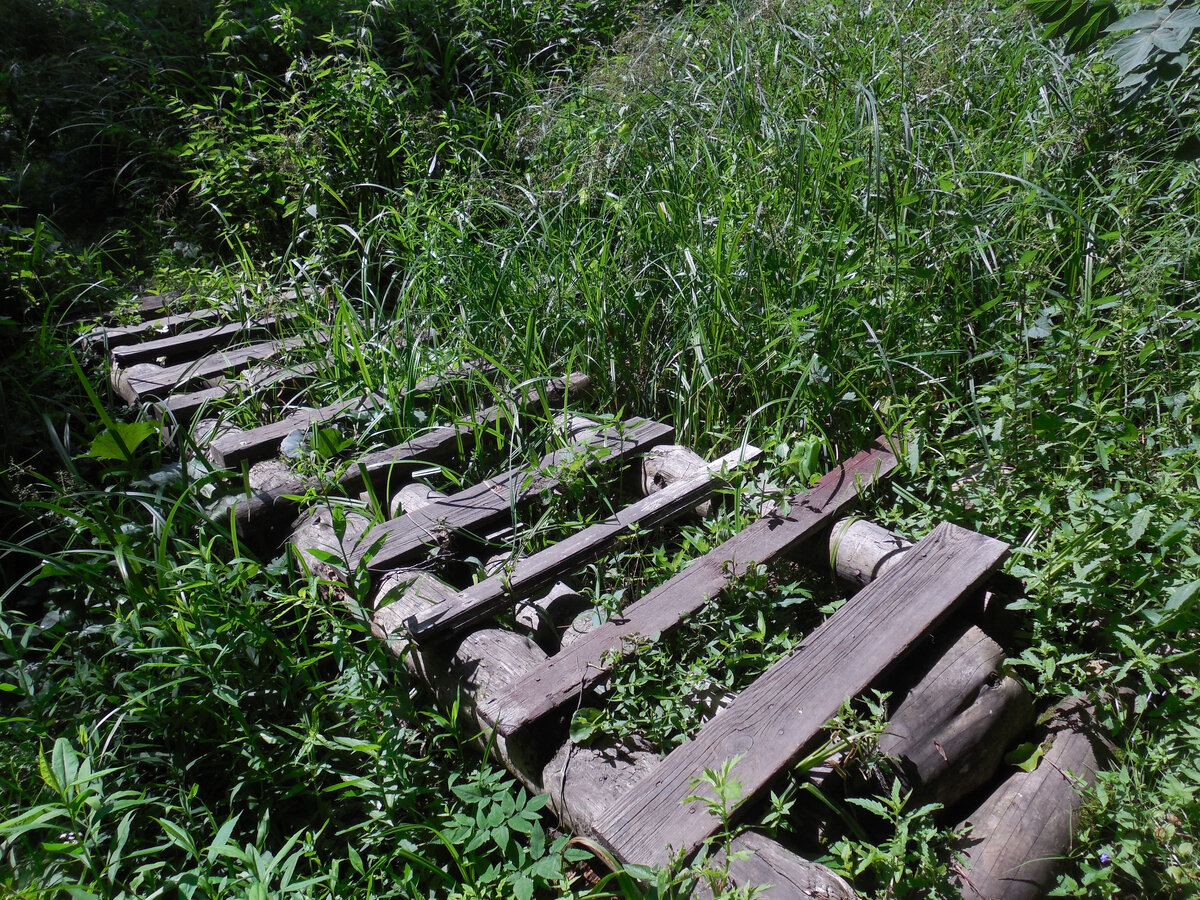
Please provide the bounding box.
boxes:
[692,832,858,900]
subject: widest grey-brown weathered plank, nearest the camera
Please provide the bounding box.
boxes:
[596,522,1008,865]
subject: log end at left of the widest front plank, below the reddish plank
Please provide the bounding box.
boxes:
[541,734,659,836]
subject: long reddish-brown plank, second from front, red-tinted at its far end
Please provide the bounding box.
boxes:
[496,440,896,736]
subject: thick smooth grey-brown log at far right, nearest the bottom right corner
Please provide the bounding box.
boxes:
[959,697,1112,900]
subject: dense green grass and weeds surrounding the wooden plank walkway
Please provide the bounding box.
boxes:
[0,0,1200,898]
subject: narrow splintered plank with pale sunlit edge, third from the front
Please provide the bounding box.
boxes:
[408,446,760,642]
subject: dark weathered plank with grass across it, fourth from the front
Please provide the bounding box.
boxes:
[352,421,674,572]
